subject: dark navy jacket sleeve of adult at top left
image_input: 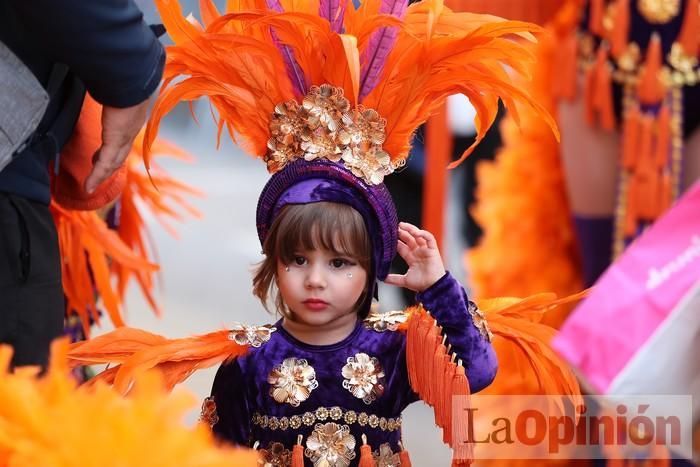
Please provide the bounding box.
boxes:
[13,0,165,107]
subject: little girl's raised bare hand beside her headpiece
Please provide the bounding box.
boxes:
[384,222,445,292]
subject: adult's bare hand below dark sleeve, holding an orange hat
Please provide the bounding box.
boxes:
[85,99,149,193]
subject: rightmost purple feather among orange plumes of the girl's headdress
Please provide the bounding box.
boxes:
[360,0,408,100]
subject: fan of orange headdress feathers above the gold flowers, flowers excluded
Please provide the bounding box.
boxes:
[144,0,558,176]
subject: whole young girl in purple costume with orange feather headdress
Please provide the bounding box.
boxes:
[71,0,576,467]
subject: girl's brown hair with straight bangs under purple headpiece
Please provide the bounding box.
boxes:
[253,201,373,319]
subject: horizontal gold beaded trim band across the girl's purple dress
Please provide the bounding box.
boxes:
[252,406,401,431]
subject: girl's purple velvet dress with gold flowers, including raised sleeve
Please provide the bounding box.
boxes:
[205,273,497,466]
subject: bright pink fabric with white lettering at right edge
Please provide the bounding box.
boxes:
[552,182,700,393]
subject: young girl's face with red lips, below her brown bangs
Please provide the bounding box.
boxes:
[277,248,367,326]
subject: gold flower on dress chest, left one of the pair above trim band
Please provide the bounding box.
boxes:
[267,357,318,407]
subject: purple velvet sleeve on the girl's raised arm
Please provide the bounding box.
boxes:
[416,272,498,393]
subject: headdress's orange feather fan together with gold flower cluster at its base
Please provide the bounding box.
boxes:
[144,0,557,175]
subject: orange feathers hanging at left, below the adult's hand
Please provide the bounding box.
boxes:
[51,132,201,337]
